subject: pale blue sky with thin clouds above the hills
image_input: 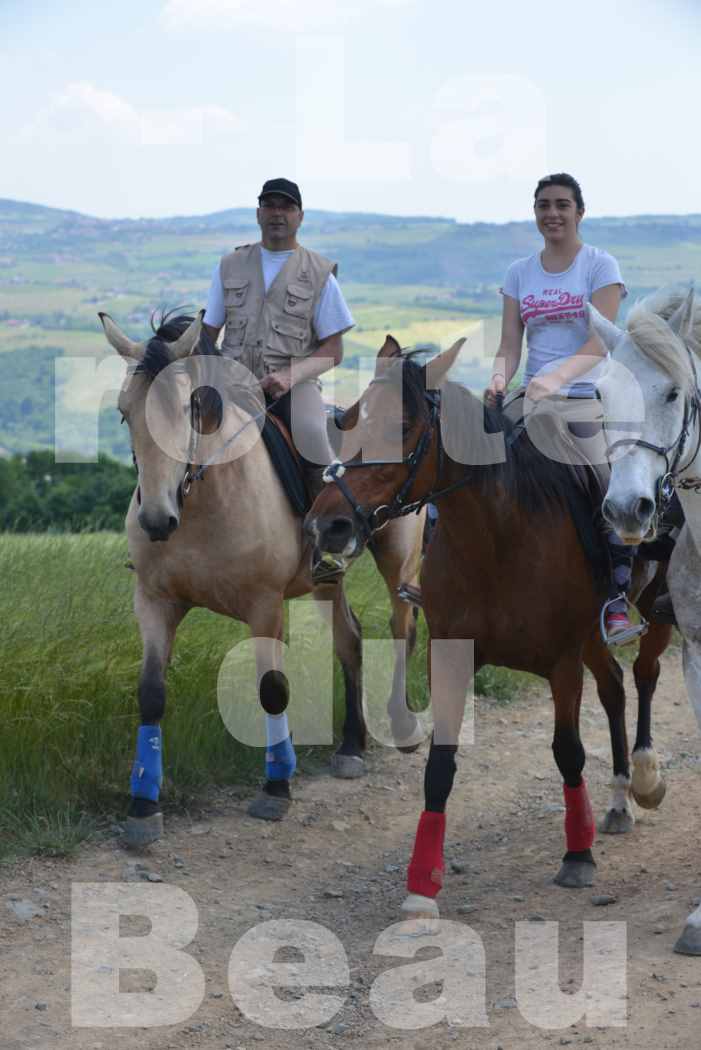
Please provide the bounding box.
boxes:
[0,0,701,222]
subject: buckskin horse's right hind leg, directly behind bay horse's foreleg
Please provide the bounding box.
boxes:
[371,516,426,752]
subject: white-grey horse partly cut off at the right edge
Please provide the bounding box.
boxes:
[590,287,701,956]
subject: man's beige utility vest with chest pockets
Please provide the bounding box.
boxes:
[220,244,337,379]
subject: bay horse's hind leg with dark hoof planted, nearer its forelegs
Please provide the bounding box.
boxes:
[585,634,635,835]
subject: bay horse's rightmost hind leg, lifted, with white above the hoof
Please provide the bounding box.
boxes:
[632,624,672,810]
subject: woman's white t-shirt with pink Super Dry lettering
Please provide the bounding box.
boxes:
[502,245,628,397]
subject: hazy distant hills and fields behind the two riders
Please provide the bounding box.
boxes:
[0,200,701,456]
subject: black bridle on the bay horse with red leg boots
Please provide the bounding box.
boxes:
[322,379,478,543]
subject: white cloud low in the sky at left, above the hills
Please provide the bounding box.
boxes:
[15,81,241,146]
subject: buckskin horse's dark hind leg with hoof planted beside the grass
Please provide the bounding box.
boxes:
[314,583,367,780]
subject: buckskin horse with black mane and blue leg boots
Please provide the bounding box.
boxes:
[100,313,423,846]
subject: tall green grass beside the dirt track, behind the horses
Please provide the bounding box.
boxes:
[0,532,524,856]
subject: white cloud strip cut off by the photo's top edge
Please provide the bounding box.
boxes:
[162,0,413,33]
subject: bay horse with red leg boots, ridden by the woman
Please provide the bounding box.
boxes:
[306,336,672,917]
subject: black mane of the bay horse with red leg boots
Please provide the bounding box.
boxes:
[394,351,586,512]
